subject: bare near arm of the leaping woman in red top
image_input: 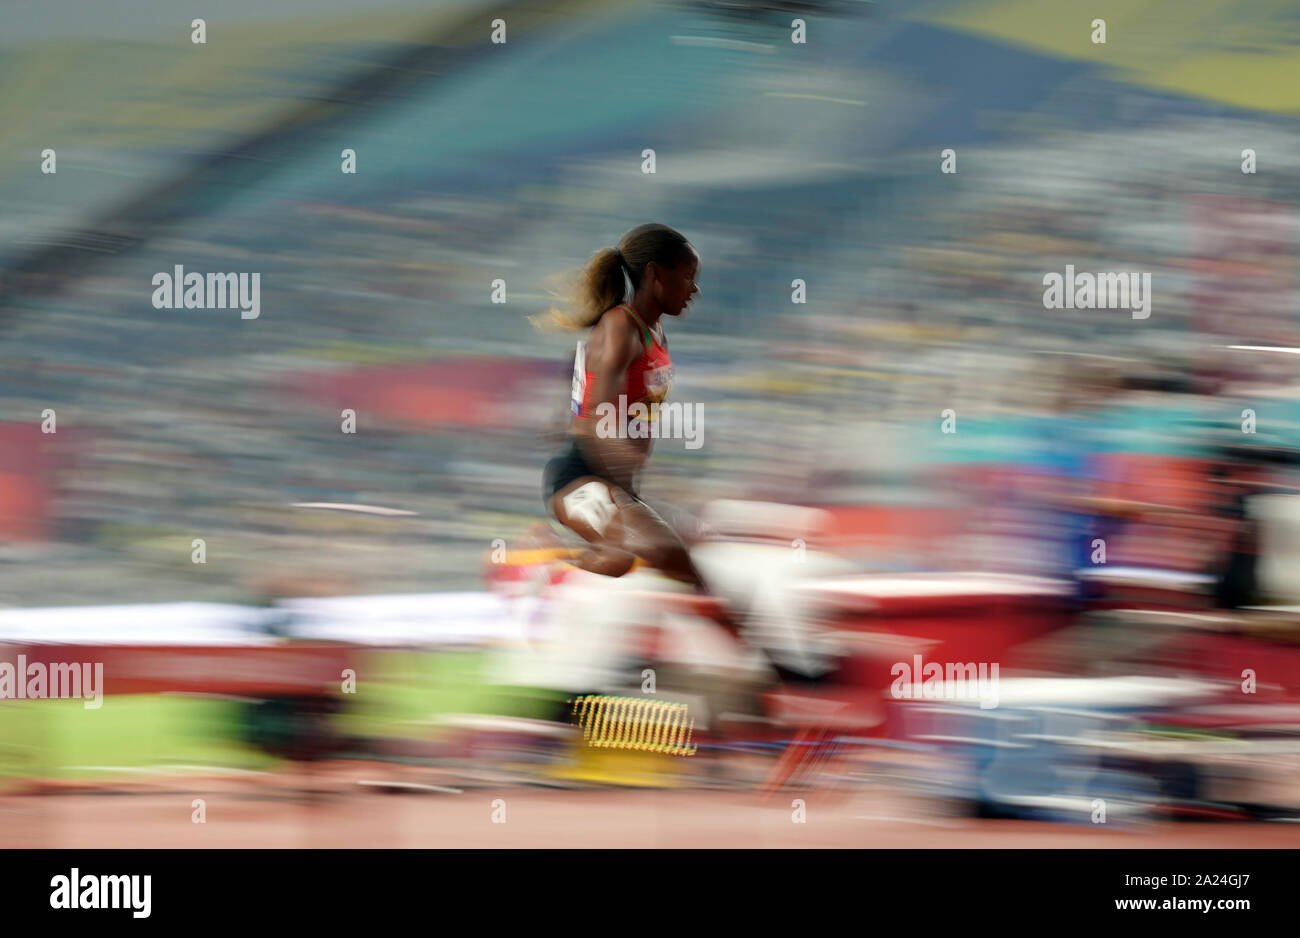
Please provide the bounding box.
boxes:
[573,313,650,491]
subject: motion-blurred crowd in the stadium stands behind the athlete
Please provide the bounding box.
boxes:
[0,1,1300,604]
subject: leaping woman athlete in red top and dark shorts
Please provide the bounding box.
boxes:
[542,225,705,591]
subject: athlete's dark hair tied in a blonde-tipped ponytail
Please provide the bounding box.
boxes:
[529,223,693,330]
